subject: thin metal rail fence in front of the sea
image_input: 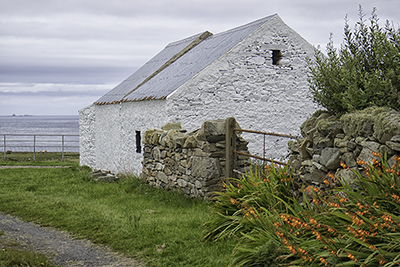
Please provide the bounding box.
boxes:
[0,134,79,162]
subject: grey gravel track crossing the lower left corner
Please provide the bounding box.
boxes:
[0,213,145,267]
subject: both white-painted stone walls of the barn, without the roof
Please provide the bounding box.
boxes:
[80,17,318,174]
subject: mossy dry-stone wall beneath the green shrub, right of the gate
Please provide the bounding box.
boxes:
[289,108,400,189]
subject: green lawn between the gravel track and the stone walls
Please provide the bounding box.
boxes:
[0,162,235,266]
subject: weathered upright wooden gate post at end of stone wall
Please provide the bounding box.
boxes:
[225,117,236,178]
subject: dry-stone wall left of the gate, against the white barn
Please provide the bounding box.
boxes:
[141,119,249,199]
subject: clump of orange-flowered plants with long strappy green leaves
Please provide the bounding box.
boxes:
[207,154,400,266]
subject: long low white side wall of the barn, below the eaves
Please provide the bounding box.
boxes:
[80,100,166,174]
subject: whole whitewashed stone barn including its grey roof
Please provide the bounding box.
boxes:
[79,14,317,174]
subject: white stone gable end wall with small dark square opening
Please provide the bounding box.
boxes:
[167,18,318,159]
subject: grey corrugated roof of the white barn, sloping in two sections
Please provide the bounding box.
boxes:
[95,15,276,104]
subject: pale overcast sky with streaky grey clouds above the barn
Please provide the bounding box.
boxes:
[0,0,400,115]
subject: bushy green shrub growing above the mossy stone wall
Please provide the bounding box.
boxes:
[309,6,400,115]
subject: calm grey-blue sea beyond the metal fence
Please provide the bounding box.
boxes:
[0,115,79,152]
